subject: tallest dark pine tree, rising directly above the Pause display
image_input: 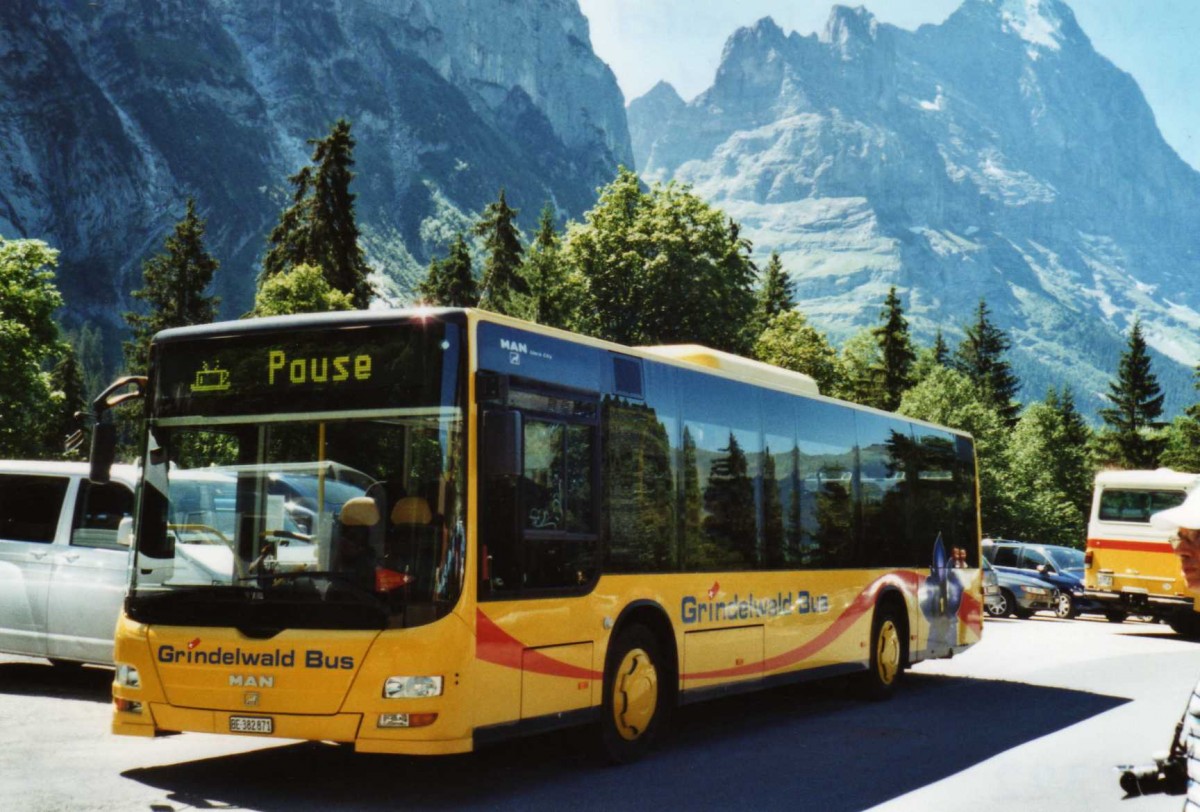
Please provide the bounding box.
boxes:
[259,119,372,309]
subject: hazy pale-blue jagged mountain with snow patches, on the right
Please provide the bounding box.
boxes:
[629,0,1200,410]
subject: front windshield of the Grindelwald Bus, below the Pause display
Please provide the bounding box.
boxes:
[128,314,466,632]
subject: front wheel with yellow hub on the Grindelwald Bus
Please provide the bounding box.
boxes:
[600,625,671,764]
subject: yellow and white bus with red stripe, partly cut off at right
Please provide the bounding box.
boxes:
[1084,468,1200,636]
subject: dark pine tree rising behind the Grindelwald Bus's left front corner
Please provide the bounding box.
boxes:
[125,198,221,374]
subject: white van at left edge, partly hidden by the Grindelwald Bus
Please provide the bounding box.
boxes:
[0,461,137,664]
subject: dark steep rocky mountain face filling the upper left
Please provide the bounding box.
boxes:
[0,0,632,357]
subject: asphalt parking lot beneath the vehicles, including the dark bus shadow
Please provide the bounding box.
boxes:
[0,615,1200,812]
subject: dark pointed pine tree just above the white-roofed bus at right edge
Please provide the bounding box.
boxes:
[1100,319,1164,469]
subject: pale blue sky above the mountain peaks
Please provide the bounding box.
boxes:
[580,0,1200,168]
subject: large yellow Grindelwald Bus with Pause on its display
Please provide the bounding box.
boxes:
[92,308,982,762]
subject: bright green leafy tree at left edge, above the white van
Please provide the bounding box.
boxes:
[0,237,64,457]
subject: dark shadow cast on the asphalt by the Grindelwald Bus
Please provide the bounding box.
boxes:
[122,674,1128,812]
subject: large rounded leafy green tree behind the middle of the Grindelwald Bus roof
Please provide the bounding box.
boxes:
[563,168,755,354]
